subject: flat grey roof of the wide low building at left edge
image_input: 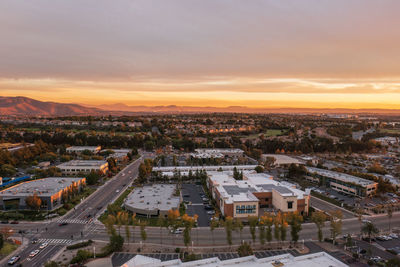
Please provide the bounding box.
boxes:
[0,177,85,197]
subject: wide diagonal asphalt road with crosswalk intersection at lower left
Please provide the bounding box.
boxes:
[7,158,141,267]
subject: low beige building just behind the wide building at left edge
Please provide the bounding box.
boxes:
[57,160,108,176]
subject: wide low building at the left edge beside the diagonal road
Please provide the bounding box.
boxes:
[0,177,86,210]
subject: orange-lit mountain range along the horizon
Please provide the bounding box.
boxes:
[0,96,400,116]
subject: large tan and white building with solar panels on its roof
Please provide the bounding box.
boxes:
[207,172,310,218]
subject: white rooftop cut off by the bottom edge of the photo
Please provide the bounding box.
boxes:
[121,252,348,267]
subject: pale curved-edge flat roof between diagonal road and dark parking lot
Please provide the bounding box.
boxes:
[124,184,180,214]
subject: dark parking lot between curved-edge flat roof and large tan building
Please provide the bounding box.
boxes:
[182,184,213,227]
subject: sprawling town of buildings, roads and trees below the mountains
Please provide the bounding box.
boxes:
[0,113,400,266]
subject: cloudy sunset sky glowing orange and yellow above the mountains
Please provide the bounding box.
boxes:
[0,0,400,109]
